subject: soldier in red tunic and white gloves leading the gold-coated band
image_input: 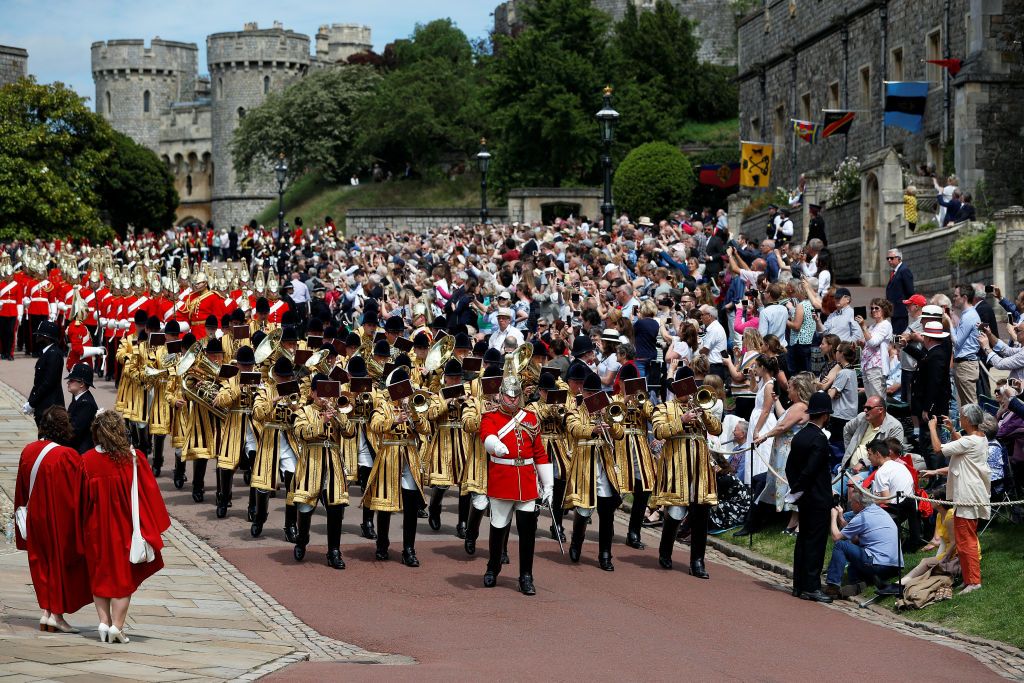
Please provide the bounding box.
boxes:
[480,377,554,595]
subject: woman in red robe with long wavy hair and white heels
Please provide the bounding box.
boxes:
[82,411,171,643]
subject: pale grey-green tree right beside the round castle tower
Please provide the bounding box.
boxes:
[231,66,380,182]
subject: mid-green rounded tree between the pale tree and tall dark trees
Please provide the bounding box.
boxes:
[357,19,483,174]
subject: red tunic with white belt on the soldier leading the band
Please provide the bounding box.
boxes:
[480,411,551,502]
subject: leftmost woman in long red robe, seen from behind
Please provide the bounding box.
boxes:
[14,405,92,633]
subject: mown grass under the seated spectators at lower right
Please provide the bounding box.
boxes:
[715,520,1024,647]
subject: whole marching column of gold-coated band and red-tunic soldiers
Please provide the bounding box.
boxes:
[12,244,721,595]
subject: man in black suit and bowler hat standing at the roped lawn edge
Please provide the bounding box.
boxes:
[785,391,833,602]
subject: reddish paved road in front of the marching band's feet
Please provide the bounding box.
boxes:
[0,359,995,681]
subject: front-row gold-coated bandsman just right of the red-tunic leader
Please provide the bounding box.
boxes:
[564,373,624,571]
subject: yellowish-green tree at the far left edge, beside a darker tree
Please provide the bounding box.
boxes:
[0,78,112,240]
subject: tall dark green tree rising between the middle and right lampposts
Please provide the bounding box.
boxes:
[486,0,608,189]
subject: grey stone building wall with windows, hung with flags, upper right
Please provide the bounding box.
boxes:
[738,0,970,192]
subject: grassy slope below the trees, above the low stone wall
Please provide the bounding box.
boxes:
[256,173,480,226]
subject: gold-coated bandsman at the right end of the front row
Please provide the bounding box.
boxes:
[650,367,722,579]
